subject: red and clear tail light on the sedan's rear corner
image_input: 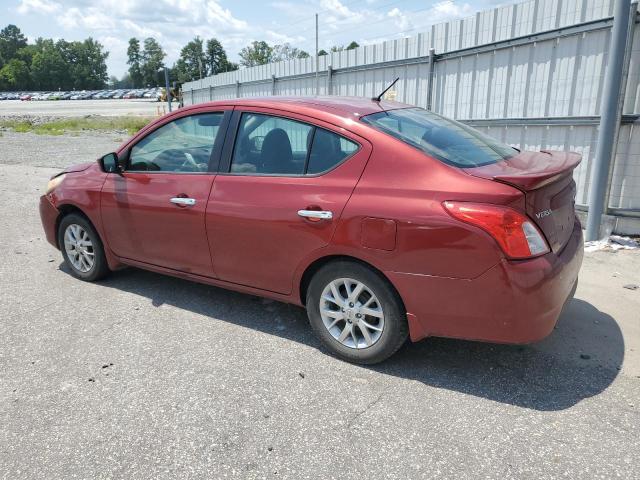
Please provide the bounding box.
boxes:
[442,201,549,259]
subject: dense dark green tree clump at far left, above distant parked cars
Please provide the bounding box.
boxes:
[0,25,109,90]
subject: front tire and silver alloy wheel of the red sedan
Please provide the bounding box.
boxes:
[58,213,110,282]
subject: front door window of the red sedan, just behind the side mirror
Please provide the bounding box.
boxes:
[127,112,224,173]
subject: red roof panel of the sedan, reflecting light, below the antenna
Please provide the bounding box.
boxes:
[181,96,413,118]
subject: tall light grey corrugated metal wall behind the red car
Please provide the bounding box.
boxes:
[183,0,640,216]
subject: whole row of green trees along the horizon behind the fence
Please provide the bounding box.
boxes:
[0,21,359,91]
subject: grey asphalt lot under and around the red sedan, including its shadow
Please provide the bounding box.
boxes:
[0,124,640,479]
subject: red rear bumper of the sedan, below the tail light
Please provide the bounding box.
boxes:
[387,220,583,343]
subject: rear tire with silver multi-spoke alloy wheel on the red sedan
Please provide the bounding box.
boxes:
[306,260,409,365]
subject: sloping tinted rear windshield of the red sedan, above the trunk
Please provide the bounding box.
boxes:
[362,108,518,168]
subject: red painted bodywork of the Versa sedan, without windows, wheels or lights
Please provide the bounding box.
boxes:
[40,97,582,343]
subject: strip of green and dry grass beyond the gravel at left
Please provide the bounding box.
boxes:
[0,116,153,135]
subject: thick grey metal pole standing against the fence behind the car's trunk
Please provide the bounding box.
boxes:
[585,0,635,241]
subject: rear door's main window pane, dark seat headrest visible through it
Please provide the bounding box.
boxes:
[231,113,313,175]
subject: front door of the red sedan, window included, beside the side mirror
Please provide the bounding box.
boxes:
[101,109,231,277]
